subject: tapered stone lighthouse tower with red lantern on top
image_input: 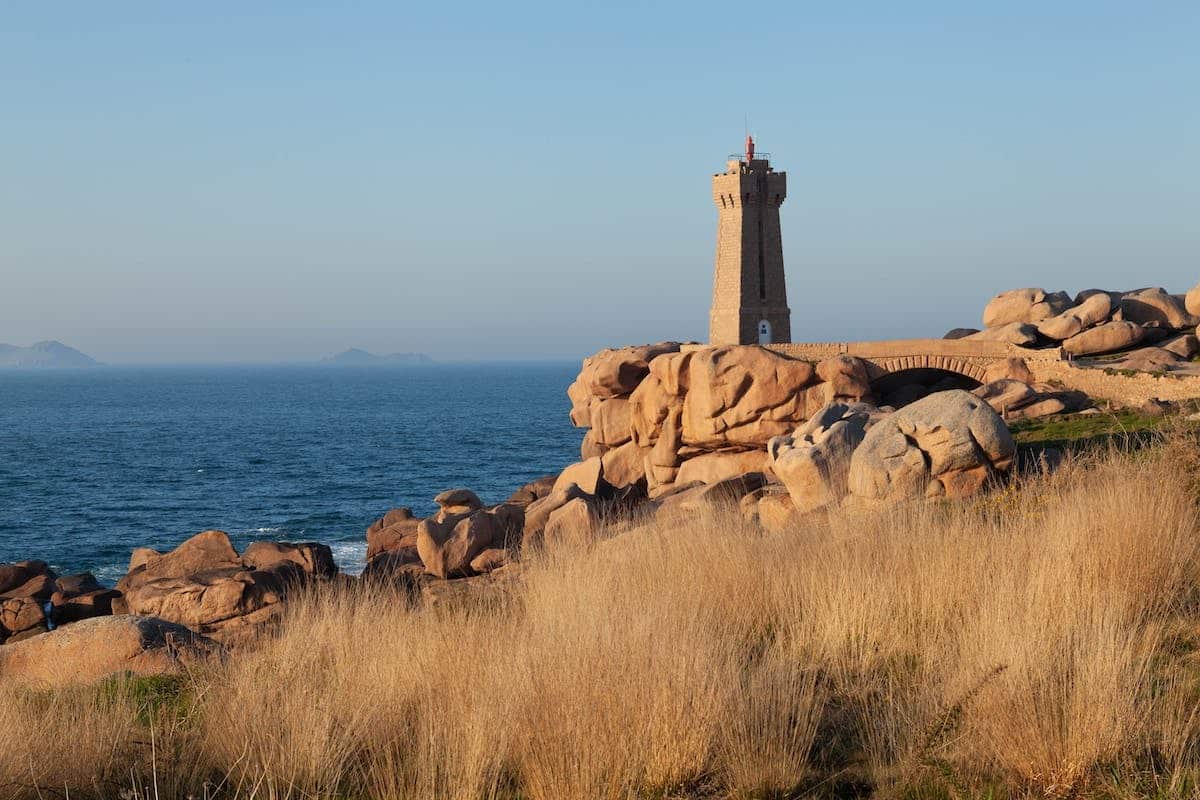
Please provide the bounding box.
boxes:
[708,136,792,344]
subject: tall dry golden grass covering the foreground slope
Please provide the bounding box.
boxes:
[0,441,1200,800]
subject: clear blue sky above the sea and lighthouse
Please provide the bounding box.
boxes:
[0,0,1200,362]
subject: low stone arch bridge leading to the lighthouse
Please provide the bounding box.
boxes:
[766,339,1063,383]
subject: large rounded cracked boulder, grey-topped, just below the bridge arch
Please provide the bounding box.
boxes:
[848,391,1016,501]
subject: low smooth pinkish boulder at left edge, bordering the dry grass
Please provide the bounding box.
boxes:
[0,615,220,688]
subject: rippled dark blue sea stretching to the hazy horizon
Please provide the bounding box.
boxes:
[0,363,582,581]
